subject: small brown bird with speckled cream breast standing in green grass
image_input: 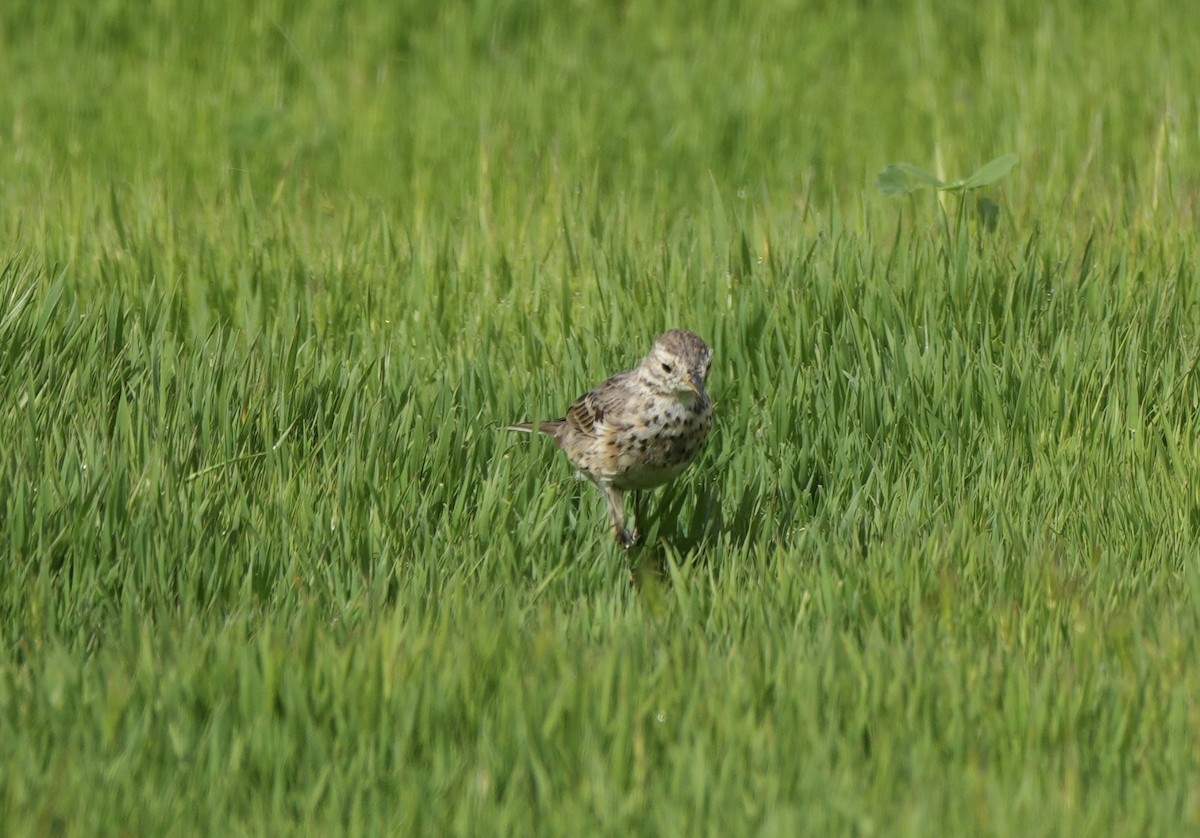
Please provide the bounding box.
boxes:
[506,329,713,550]
